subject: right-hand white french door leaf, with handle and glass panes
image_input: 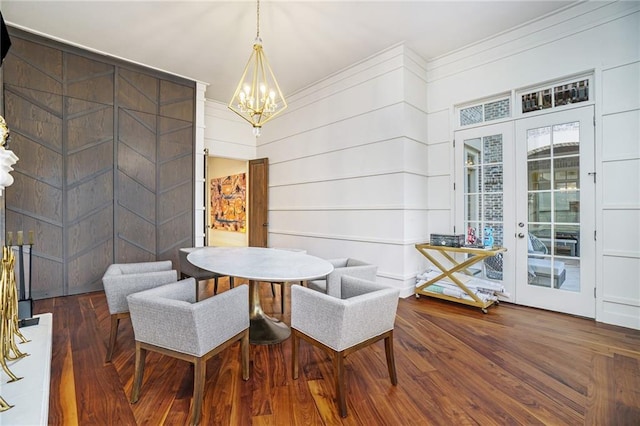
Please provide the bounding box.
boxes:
[515,106,595,318]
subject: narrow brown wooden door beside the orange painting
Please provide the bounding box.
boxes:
[249,158,269,247]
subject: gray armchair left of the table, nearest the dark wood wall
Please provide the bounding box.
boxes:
[102,260,178,362]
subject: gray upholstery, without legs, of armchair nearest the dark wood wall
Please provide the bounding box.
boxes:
[102,270,178,314]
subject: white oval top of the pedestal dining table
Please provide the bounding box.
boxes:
[187,247,333,282]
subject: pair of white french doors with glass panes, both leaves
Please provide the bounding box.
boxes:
[455,106,595,317]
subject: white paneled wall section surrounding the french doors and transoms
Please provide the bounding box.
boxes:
[427,2,640,328]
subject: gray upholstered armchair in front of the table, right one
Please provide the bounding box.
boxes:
[291,275,400,417]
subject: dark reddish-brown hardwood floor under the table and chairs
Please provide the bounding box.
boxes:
[36,281,640,426]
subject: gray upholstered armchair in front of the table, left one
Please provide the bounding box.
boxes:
[127,278,249,424]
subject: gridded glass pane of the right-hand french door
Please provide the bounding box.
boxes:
[527,122,580,291]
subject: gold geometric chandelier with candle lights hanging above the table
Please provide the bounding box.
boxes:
[229,0,287,136]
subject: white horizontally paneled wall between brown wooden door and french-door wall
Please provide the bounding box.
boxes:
[257,46,427,295]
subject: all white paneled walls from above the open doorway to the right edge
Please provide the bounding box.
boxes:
[201,2,640,328]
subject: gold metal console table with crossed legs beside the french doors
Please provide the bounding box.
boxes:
[415,244,507,314]
